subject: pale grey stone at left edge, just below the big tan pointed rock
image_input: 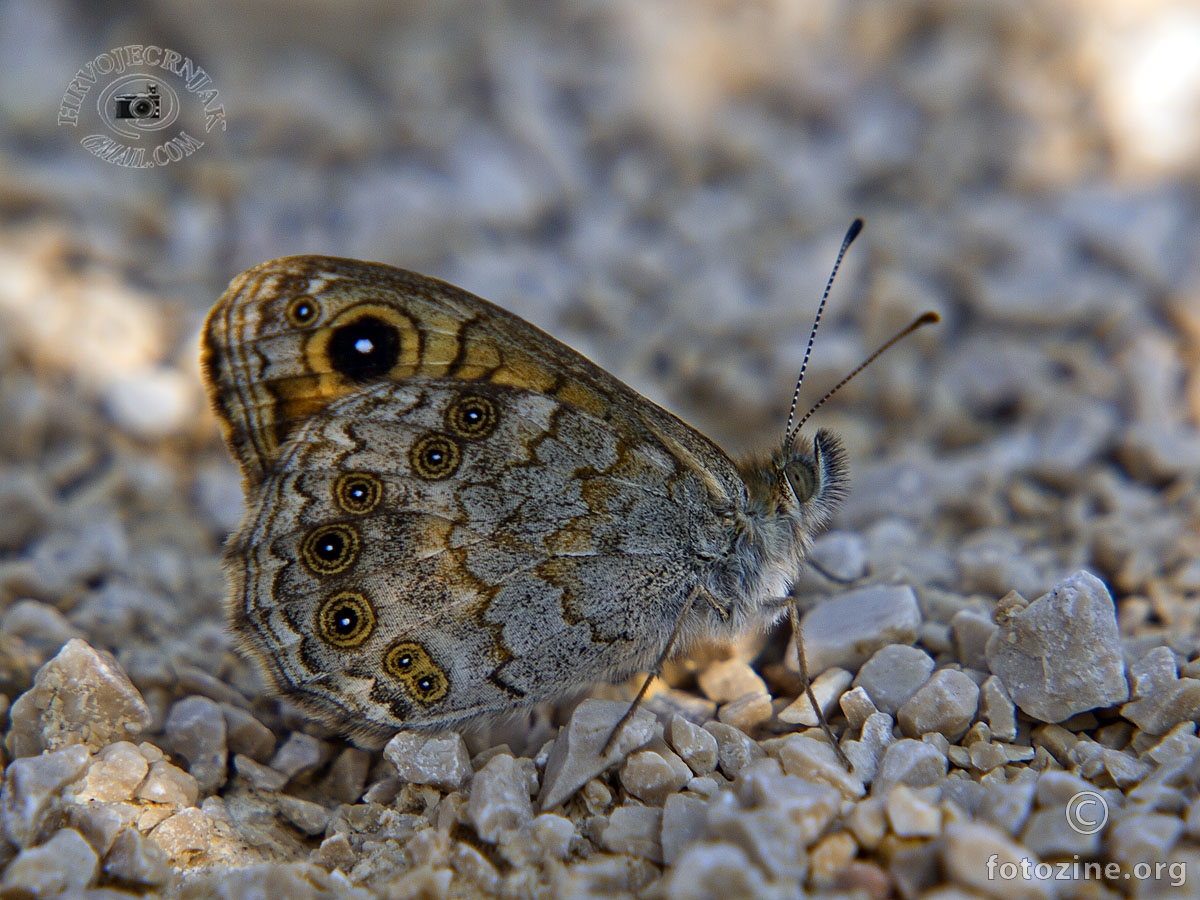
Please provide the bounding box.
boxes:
[0,744,90,848]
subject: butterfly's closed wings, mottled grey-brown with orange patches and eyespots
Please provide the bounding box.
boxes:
[205,257,744,731]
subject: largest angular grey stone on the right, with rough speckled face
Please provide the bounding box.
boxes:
[988,571,1129,722]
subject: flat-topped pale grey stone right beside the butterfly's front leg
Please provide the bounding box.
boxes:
[801,584,920,676]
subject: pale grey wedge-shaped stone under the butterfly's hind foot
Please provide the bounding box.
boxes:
[538,698,657,811]
